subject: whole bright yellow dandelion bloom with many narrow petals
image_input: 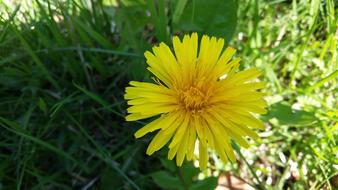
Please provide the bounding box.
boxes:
[125,33,267,169]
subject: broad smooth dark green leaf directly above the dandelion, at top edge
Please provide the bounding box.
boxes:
[173,0,238,43]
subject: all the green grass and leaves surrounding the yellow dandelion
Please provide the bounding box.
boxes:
[0,0,338,190]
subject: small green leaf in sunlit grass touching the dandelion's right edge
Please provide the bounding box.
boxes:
[262,102,317,125]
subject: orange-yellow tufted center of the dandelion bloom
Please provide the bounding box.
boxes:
[180,86,207,111]
